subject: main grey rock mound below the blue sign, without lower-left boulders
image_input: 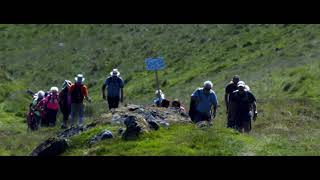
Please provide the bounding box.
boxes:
[100,104,191,140]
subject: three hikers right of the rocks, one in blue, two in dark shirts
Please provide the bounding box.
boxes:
[189,75,258,133]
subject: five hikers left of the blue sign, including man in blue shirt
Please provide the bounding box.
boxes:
[27,69,124,130]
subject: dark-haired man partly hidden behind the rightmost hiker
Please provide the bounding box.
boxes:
[224,75,240,128]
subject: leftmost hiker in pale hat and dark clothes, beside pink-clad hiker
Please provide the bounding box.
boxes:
[27,91,45,130]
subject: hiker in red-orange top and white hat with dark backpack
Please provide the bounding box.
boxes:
[69,74,91,127]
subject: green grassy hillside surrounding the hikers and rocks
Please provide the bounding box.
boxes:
[0,25,320,155]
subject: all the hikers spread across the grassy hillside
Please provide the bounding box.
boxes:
[28,69,257,132]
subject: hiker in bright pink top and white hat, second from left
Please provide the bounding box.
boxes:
[44,87,59,126]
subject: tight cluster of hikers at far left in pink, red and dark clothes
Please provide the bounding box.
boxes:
[27,74,91,130]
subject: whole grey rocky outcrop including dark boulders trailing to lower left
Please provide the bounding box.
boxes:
[31,104,191,156]
